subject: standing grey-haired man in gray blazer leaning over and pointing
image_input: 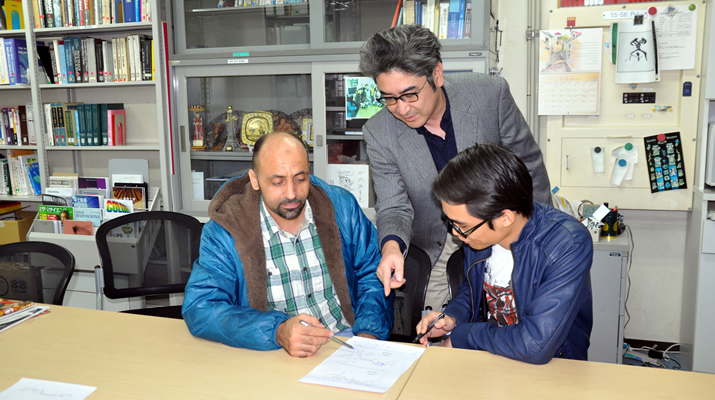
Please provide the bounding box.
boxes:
[360,25,551,311]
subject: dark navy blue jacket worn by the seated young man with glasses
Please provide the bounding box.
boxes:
[445,203,593,364]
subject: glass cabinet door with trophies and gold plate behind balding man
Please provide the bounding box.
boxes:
[176,64,313,214]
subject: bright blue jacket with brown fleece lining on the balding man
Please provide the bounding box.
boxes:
[182,174,393,350]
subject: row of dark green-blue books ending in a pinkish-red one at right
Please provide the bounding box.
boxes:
[44,103,127,146]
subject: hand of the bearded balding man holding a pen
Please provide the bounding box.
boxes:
[276,314,333,357]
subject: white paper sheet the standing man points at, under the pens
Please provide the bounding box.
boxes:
[300,336,425,393]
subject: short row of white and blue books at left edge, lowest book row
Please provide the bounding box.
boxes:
[0,150,42,196]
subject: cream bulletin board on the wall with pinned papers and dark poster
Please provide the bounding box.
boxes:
[542,1,707,210]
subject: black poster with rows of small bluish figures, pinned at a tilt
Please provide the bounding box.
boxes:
[643,132,688,193]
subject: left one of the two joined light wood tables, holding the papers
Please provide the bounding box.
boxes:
[0,306,414,400]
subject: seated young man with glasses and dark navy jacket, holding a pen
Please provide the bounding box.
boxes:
[417,144,593,364]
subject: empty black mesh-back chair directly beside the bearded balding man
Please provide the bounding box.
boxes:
[95,211,203,319]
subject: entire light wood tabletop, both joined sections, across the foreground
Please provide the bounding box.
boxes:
[0,306,715,400]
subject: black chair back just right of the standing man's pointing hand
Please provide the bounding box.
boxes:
[390,245,432,343]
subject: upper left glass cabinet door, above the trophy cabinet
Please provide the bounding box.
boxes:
[175,0,310,53]
